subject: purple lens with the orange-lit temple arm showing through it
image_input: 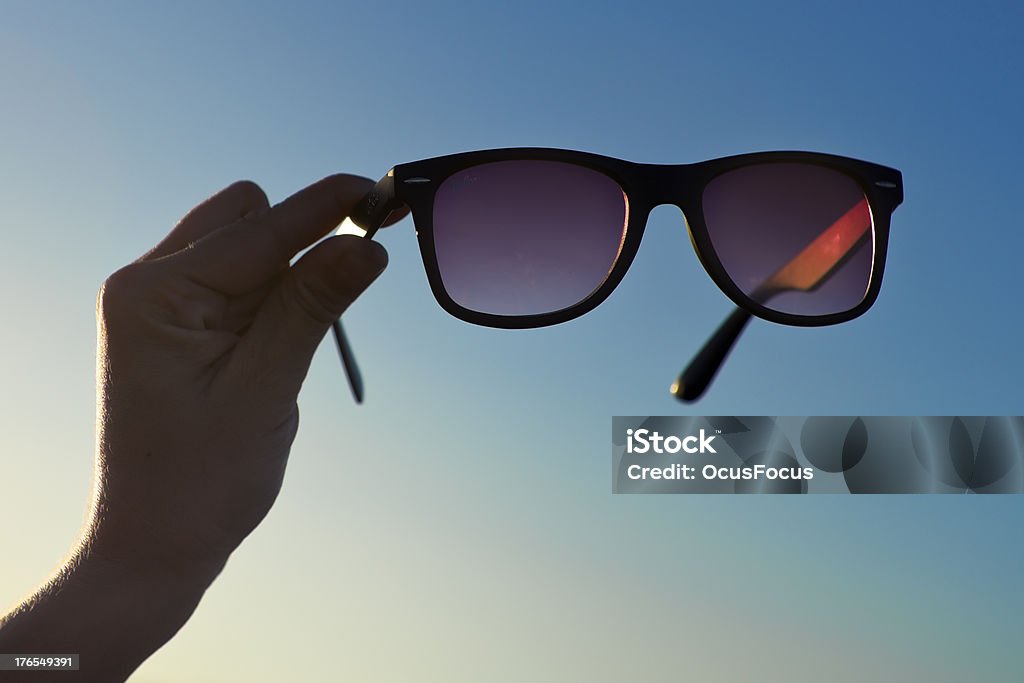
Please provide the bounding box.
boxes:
[703,163,874,315]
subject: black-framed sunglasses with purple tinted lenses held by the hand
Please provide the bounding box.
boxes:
[334,148,903,402]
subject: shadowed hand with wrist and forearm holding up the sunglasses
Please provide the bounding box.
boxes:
[0,175,394,682]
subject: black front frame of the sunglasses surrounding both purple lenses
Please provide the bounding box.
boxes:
[351,147,903,329]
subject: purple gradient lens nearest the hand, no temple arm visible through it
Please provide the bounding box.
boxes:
[433,161,628,315]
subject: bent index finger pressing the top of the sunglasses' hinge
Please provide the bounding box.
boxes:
[167,174,374,296]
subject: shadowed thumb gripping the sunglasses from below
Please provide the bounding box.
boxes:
[224,236,387,397]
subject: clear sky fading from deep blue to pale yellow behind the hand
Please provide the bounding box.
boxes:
[0,0,1024,683]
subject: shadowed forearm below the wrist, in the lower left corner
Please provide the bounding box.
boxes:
[0,550,223,683]
